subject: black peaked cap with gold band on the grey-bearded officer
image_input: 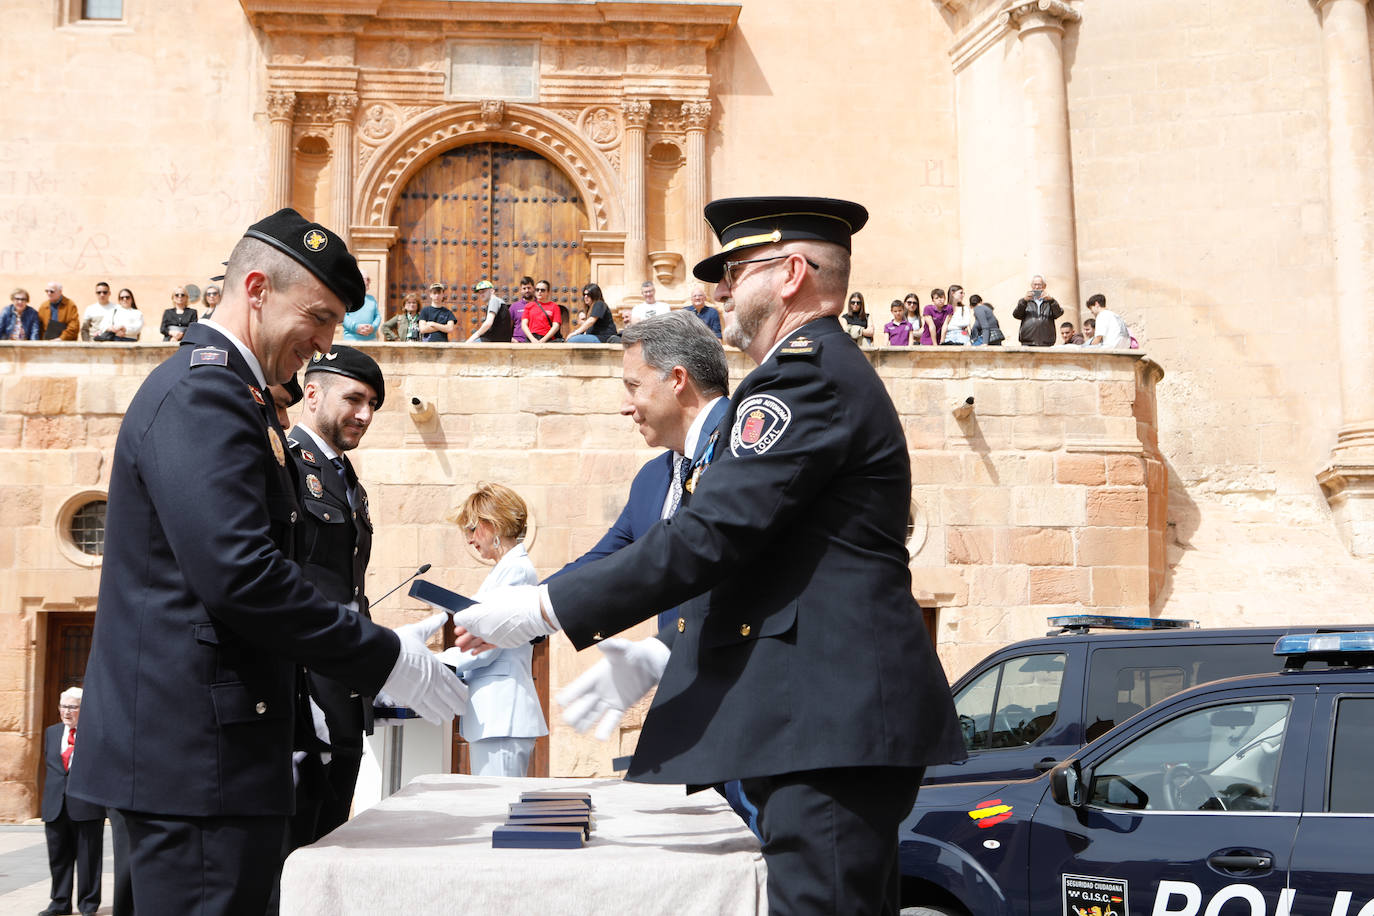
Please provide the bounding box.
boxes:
[692,198,868,283]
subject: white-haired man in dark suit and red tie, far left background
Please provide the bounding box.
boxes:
[38,687,104,916]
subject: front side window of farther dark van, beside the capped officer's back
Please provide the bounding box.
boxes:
[954,652,1065,751]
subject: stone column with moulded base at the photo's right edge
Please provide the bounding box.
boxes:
[1314,0,1374,556]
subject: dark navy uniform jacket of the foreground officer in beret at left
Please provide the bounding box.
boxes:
[69,321,398,816]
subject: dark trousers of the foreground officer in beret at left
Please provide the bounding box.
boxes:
[120,810,286,916]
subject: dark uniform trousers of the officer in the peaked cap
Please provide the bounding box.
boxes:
[741,766,925,916]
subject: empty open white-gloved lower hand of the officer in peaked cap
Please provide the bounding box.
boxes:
[558,637,669,742]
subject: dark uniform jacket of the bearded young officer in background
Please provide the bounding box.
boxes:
[286,426,372,748]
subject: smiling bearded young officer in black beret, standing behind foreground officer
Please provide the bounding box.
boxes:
[286,345,386,849]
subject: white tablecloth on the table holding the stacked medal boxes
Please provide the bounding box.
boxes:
[282,776,768,916]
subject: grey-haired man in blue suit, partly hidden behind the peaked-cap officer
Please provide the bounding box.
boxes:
[551,312,730,626]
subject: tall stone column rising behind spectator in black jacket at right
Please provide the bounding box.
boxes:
[1002,0,1083,324]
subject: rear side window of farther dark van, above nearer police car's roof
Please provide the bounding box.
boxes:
[1084,643,1279,742]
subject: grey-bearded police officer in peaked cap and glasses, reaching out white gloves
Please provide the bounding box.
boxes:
[455,198,963,913]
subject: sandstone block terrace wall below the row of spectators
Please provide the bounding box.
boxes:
[0,342,1165,820]
